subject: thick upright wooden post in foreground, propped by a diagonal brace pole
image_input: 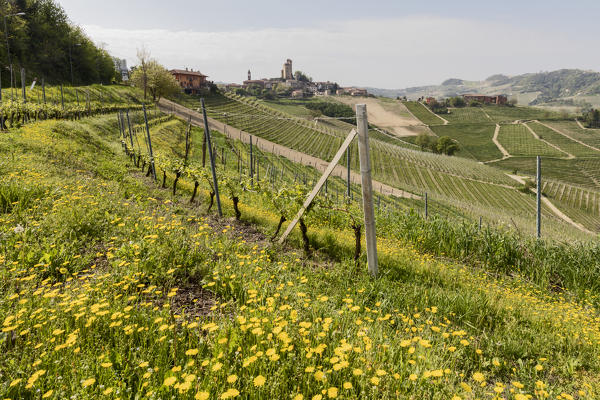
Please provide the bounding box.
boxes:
[356,104,379,276]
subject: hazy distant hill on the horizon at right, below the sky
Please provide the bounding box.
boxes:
[368,69,600,107]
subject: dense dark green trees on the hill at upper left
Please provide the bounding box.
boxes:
[0,0,121,87]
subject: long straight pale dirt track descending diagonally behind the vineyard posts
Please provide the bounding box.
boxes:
[158,99,421,200]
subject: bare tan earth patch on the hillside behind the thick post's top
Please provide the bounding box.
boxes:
[334,96,423,137]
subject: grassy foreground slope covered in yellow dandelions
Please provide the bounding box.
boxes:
[0,108,600,399]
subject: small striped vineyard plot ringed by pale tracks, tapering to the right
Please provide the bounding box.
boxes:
[498,124,564,157]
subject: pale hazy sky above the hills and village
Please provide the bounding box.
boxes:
[58,0,600,89]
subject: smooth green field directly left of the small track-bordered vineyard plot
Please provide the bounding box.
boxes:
[431,123,502,161]
